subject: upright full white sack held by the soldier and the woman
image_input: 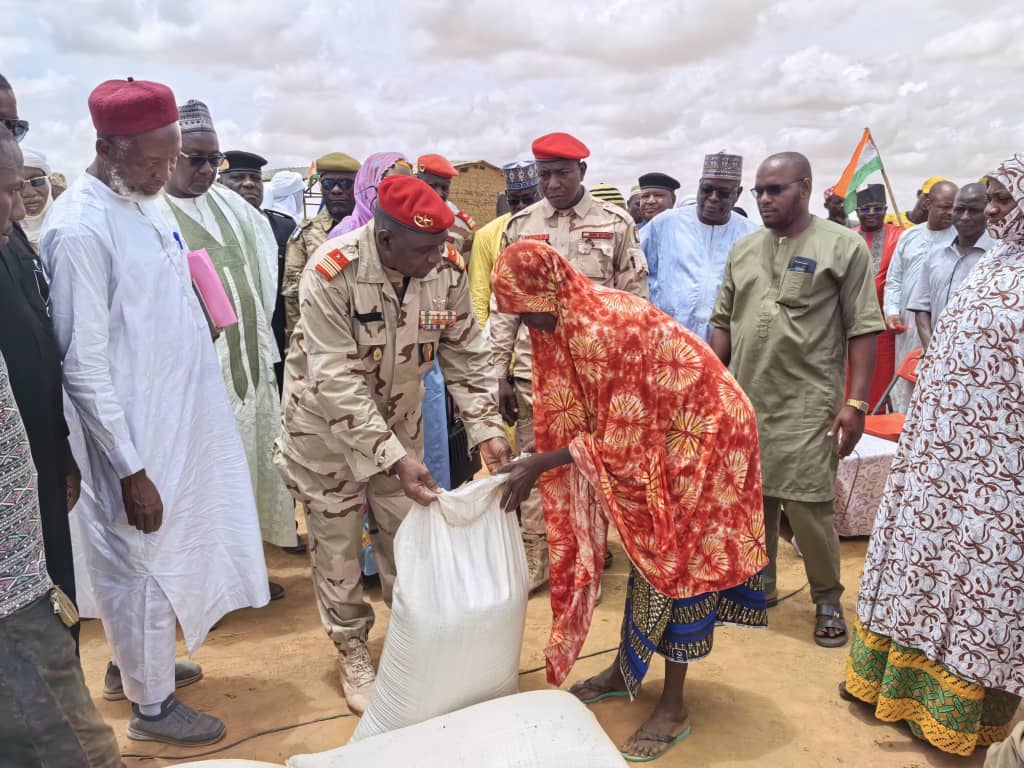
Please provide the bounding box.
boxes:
[352,476,528,741]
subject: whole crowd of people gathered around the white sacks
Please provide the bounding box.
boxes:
[0,67,1024,766]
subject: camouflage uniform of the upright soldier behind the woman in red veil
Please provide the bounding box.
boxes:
[490,191,649,536]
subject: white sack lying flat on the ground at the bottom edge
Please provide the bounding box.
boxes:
[285,690,626,768]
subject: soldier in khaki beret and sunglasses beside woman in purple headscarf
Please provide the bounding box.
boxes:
[281,152,361,335]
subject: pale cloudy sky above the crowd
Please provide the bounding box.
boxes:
[0,0,1024,218]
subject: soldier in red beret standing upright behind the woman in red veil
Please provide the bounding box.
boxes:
[490,133,648,591]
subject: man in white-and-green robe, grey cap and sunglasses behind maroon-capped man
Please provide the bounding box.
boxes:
[160,100,297,565]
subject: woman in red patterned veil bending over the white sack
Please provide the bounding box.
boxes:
[492,241,768,761]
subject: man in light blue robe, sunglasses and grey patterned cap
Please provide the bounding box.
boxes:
[640,153,758,341]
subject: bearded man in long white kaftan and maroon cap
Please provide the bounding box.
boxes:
[40,80,268,745]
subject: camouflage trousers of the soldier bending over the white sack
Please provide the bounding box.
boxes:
[273,445,413,648]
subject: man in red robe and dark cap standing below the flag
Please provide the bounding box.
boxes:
[854,184,903,409]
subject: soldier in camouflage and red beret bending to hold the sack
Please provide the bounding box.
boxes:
[274,176,511,712]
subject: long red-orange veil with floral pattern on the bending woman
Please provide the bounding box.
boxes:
[492,241,768,685]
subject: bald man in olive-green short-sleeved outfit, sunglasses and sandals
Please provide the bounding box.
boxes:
[711,153,885,647]
